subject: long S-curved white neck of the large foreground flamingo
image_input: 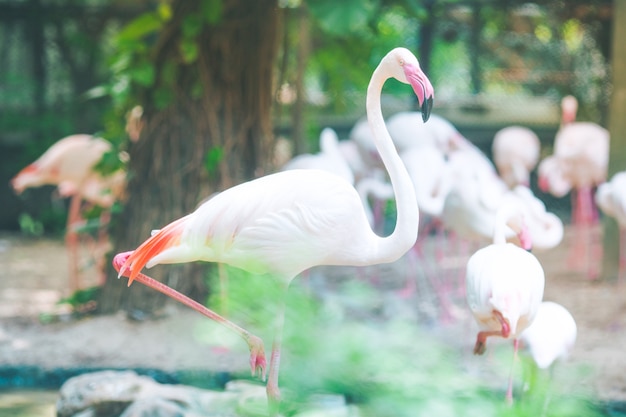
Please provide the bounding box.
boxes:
[366,60,419,262]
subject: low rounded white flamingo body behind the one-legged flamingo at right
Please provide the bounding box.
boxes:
[520,301,577,369]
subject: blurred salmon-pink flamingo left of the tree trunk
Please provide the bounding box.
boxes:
[11,134,126,291]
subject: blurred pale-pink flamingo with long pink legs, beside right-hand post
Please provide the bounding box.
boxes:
[539,96,610,279]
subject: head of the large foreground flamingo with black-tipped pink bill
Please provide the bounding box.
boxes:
[386,48,435,122]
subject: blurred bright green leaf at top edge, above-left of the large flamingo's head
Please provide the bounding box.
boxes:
[308,0,378,35]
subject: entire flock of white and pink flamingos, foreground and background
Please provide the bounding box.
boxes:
[17,48,626,416]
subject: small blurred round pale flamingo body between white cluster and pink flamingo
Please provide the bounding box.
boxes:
[491,126,541,188]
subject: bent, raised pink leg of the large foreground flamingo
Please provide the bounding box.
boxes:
[113,251,266,380]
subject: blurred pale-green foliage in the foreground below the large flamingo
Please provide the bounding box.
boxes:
[204,268,601,417]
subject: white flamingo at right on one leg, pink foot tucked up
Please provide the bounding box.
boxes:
[466,204,545,402]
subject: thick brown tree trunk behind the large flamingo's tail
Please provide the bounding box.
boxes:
[99,0,279,313]
